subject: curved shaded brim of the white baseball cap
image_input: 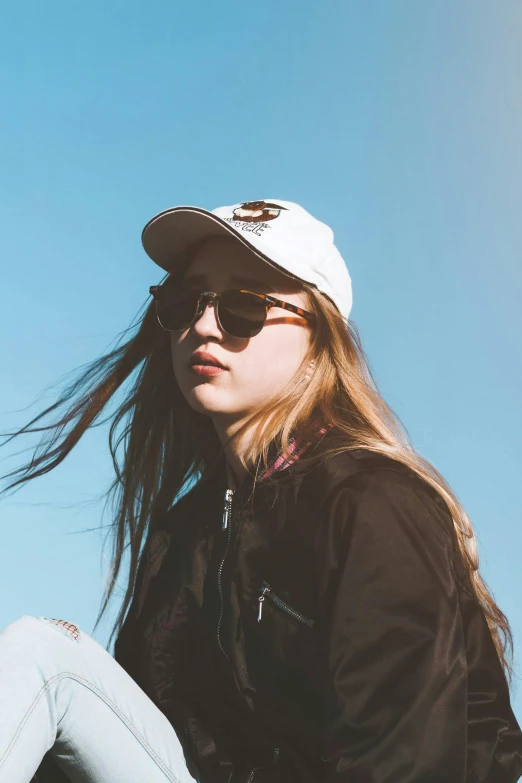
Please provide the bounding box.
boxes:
[141,206,300,280]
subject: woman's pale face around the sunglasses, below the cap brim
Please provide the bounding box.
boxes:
[171,237,310,420]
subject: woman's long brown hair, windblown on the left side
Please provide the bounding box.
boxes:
[3,274,513,683]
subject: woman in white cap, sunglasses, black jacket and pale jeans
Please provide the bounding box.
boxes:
[0,200,522,783]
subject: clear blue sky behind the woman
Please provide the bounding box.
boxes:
[0,0,522,721]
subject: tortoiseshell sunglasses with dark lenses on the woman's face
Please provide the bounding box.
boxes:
[149,280,314,337]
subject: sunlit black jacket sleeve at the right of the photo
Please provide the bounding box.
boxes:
[323,470,522,783]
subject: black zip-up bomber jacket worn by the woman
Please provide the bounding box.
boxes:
[31,436,522,783]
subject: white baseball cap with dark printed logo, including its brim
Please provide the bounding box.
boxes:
[141,199,352,319]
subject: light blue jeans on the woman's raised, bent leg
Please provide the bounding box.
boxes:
[0,616,198,783]
